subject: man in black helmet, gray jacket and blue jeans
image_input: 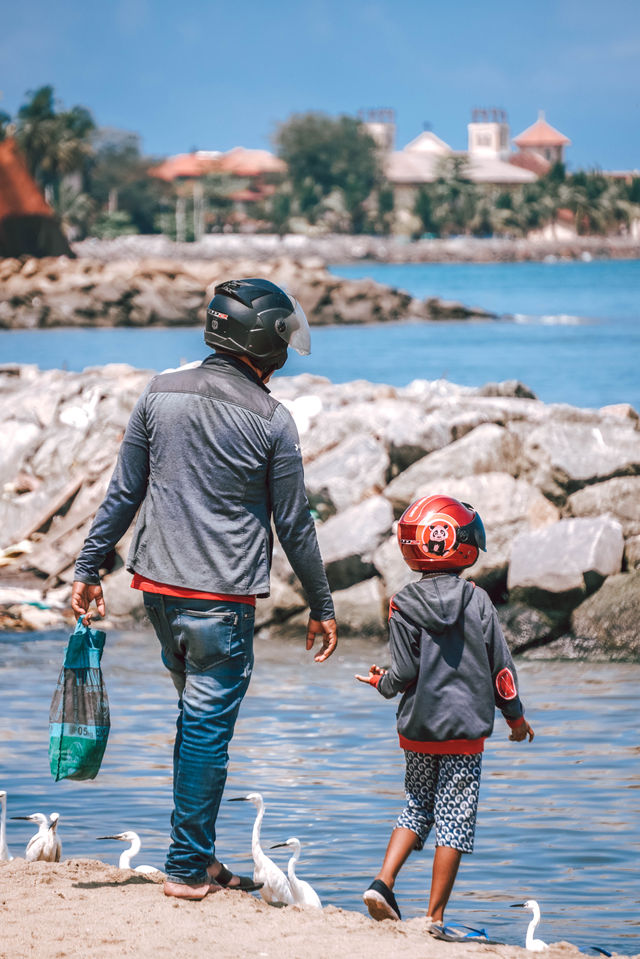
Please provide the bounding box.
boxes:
[71,279,337,899]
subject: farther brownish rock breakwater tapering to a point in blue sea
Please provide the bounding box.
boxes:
[0,257,492,329]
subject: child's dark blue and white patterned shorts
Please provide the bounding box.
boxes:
[396,749,482,852]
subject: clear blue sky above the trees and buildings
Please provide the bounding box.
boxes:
[0,0,640,169]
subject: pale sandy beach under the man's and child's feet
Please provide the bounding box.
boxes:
[0,859,604,959]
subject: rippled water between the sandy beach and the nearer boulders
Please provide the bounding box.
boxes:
[0,631,640,954]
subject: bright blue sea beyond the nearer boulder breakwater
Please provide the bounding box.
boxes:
[0,260,640,410]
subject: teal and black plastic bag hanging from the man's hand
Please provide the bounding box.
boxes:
[49,617,110,782]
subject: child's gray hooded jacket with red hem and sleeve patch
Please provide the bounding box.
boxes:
[378,573,523,753]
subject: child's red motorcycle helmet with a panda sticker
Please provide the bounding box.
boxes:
[398,493,487,573]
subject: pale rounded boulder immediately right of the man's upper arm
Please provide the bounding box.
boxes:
[305,434,389,515]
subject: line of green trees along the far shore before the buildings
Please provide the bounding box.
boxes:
[0,86,640,239]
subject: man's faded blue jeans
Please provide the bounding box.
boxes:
[144,593,255,884]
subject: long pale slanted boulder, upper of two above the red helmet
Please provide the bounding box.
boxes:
[384,423,520,516]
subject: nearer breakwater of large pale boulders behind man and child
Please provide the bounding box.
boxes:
[0,366,640,660]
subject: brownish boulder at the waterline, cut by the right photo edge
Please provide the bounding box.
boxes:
[571,570,640,662]
